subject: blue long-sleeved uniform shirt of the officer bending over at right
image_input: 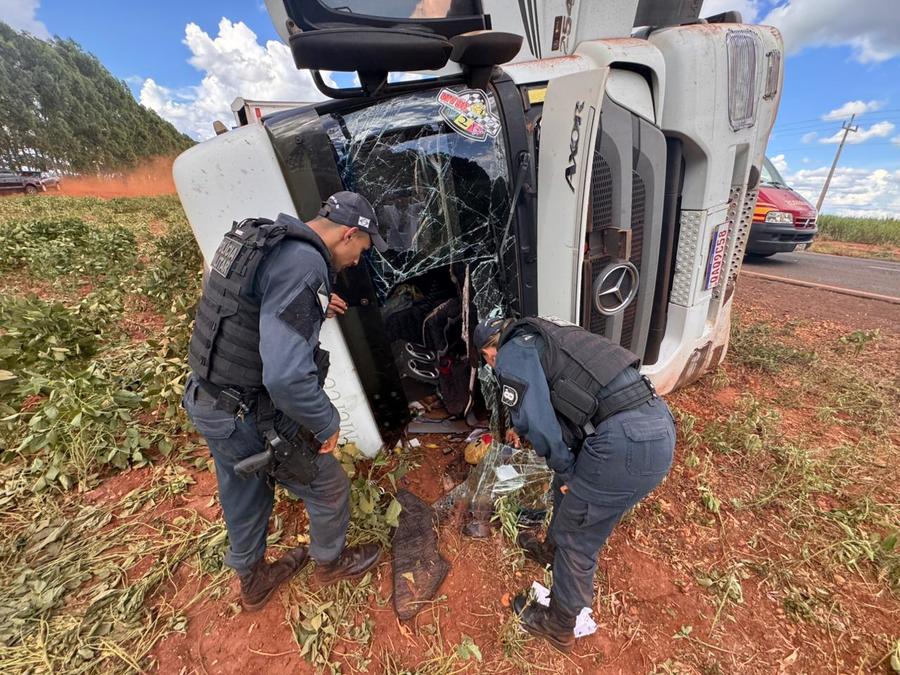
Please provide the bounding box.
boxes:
[494,334,575,481]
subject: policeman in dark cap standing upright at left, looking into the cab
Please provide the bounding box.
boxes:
[183,192,386,611]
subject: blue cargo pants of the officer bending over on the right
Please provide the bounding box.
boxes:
[547,398,675,616]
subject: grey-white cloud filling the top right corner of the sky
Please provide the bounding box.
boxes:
[762,0,900,63]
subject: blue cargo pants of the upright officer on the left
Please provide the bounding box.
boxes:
[182,377,350,574]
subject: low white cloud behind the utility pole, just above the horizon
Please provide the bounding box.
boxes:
[786,166,900,218]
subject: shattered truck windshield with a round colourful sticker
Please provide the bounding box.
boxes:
[321,87,511,305]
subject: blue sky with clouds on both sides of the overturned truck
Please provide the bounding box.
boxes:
[0,0,900,215]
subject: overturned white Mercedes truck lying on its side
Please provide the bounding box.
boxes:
[174,0,782,455]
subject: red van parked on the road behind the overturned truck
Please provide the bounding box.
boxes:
[747,157,818,258]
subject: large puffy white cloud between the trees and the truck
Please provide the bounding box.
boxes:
[140,18,324,139]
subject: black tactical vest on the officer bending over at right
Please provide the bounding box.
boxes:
[499,318,640,446]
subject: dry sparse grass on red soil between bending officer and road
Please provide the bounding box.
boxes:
[656,310,900,672]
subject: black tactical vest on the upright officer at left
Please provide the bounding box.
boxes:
[188,218,331,391]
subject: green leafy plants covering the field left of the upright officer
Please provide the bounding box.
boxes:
[0,197,418,673]
